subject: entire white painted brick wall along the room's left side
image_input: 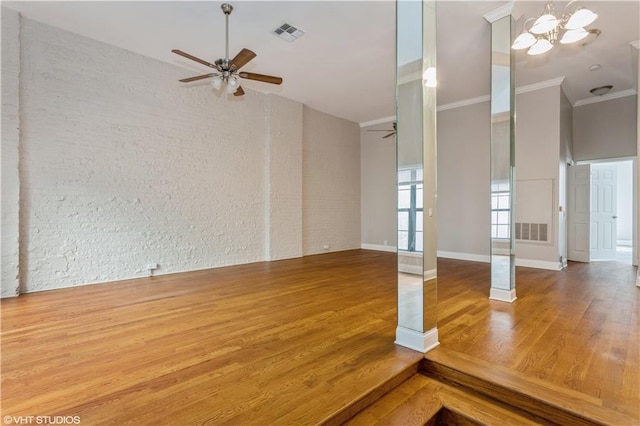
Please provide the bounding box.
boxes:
[2,9,360,296]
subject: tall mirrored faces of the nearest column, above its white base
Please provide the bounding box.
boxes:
[396,0,436,344]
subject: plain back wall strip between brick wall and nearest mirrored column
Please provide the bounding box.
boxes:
[360,121,397,250]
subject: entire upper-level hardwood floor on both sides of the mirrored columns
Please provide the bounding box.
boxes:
[1,250,640,425]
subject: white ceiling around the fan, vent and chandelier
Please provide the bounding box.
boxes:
[2,0,640,123]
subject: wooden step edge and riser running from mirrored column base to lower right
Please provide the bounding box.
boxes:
[420,347,638,425]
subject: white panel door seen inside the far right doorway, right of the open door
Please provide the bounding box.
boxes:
[591,164,618,260]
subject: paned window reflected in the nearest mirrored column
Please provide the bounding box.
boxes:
[398,168,424,252]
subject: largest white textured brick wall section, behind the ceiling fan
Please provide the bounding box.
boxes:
[22,19,267,291]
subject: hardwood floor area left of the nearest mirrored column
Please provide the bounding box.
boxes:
[2,250,422,425]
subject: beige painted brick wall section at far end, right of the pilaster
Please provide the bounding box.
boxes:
[302,107,361,255]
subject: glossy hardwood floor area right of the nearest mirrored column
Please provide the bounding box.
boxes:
[426,259,640,424]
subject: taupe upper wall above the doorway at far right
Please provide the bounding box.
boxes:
[573,95,637,161]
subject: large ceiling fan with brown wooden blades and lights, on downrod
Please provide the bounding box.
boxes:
[172,3,282,96]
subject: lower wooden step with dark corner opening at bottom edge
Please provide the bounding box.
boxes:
[346,374,545,426]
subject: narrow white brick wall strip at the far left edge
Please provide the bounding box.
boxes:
[0,7,20,297]
